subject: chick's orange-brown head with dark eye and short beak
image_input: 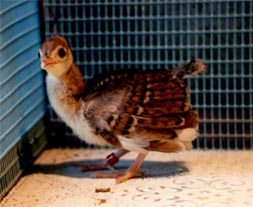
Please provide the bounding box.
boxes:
[38,35,73,78]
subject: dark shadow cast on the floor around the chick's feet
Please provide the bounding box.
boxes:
[25,160,189,178]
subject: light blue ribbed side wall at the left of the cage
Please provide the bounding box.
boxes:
[0,0,45,197]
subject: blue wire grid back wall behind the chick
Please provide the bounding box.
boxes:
[44,0,253,149]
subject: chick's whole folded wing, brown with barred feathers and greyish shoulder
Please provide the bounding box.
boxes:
[85,60,204,151]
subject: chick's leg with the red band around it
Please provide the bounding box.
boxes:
[82,149,129,172]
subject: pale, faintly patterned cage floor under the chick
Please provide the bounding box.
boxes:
[1,149,253,207]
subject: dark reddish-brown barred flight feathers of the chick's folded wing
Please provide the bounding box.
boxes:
[113,71,197,136]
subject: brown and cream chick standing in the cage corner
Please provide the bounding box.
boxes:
[39,36,206,183]
